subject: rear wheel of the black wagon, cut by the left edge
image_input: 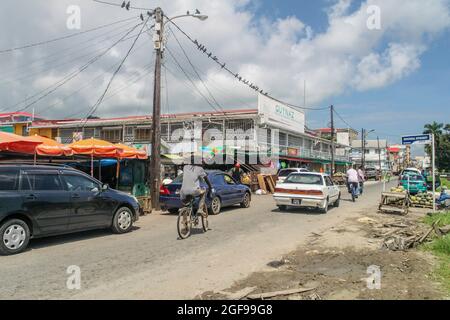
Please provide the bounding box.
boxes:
[0,219,30,255]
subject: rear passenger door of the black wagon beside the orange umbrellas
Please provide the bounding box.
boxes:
[20,170,71,235]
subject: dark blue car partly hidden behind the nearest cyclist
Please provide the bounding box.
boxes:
[159,170,251,215]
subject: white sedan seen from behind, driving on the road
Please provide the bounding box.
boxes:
[273,172,341,213]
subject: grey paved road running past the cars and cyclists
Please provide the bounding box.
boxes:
[0,184,394,299]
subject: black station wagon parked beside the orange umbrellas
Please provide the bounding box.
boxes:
[0,165,141,255]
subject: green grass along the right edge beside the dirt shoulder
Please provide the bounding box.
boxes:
[424,212,450,294]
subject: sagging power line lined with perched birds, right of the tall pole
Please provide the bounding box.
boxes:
[167,17,329,111]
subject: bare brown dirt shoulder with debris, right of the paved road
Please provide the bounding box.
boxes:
[202,205,446,300]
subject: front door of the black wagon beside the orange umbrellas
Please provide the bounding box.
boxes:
[62,173,115,231]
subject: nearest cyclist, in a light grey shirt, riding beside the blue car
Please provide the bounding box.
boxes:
[180,157,214,217]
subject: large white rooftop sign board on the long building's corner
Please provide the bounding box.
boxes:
[258,94,305,133]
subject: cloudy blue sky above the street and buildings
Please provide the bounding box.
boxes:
[0,0,450,148]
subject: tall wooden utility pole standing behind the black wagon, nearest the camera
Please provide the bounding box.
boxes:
[150,8,164,210]
